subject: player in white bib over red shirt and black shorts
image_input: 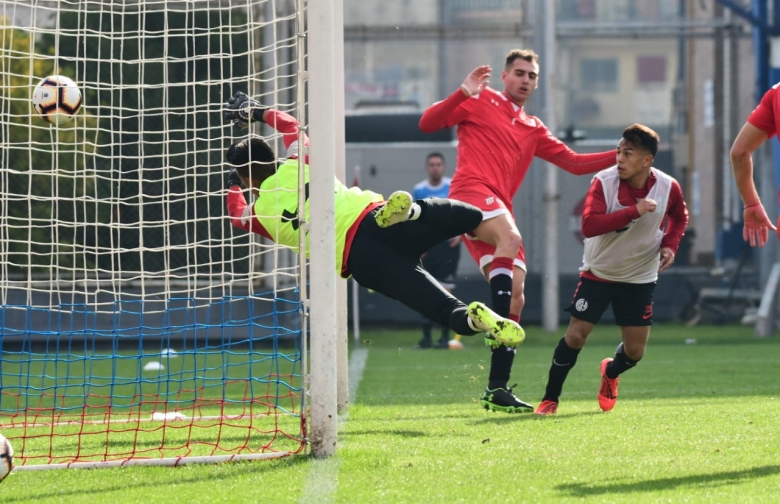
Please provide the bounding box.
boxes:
[536,124,688,415]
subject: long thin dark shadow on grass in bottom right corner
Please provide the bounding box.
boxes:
[556,465,780,497]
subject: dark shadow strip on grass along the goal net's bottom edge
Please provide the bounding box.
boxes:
[7,455,311,504]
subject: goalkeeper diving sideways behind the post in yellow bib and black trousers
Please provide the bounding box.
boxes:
[224,91,525,358]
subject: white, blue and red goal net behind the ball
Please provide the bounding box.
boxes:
[0,0,305,469]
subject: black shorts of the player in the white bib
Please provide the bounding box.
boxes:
[566,278,656,326]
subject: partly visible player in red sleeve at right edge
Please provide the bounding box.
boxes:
[731,83,780,247]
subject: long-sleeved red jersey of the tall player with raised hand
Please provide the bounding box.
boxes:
[420,88,617,208]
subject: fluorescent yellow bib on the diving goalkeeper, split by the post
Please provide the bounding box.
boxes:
[254,159,383,275]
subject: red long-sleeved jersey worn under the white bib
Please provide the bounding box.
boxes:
[580,173,688,280]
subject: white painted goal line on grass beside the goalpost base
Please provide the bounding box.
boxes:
[298,348,368,504]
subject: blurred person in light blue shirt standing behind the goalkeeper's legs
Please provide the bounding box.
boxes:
[412,152,463,349]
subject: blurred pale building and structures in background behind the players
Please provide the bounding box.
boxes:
[345,0,777,322]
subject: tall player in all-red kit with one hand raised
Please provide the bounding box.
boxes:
[420,49,615,413]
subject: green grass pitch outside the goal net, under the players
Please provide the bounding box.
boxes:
[0,324,780,504]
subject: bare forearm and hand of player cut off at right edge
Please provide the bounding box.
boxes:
[731,122,777,247]
